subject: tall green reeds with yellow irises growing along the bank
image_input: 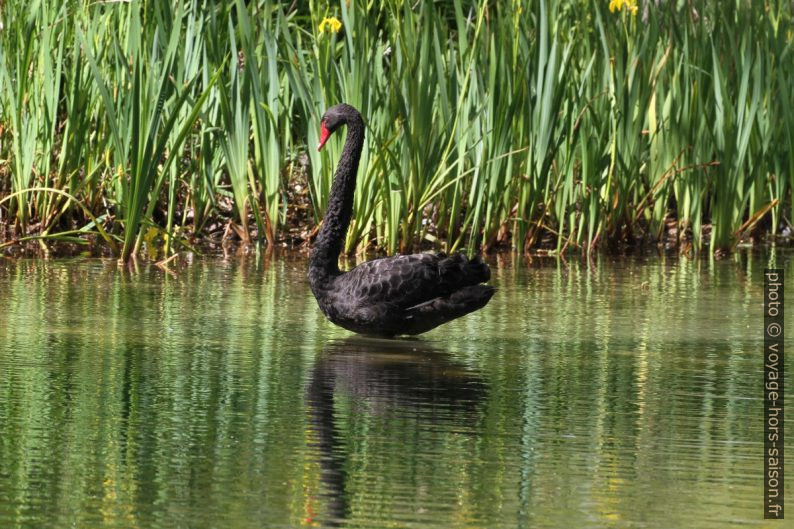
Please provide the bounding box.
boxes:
[0,0,794,259]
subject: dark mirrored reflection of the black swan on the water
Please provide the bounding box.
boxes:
[306,337,487,526]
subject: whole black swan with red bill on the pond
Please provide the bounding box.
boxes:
[309,104,495,336]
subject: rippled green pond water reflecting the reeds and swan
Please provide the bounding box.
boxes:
[0,253,794,528]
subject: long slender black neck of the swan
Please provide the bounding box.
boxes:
[309,112,364,282]
